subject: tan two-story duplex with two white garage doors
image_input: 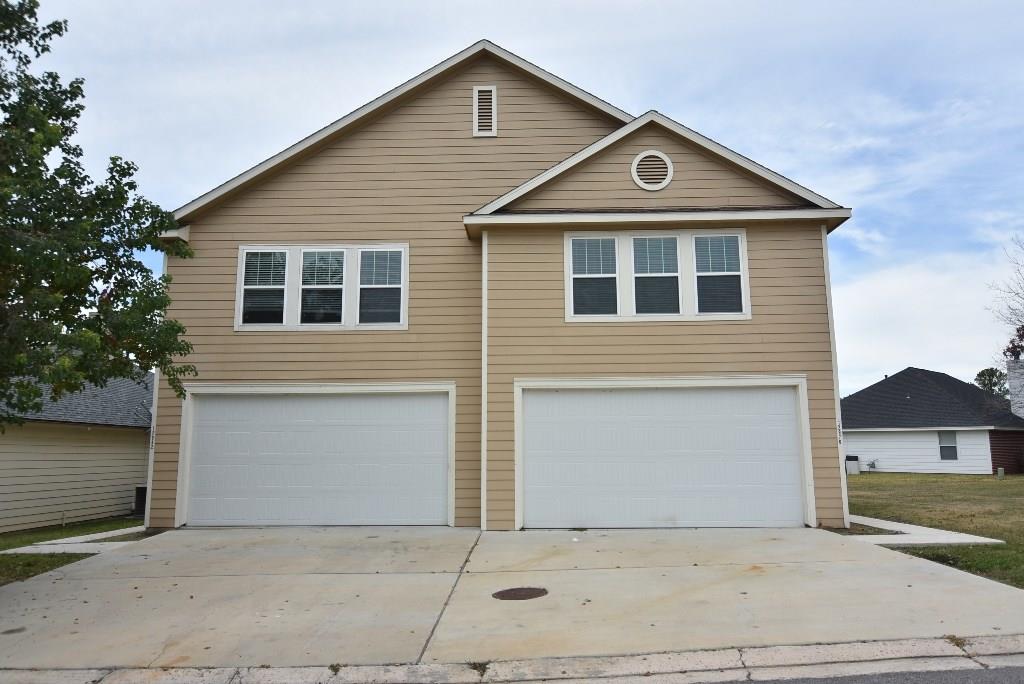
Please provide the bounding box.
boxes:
[147,41,850,529]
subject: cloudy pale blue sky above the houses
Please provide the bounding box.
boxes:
[42,0,1024,394]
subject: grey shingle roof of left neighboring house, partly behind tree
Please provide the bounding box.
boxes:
[24,373,153,428]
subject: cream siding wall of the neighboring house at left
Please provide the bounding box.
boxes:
[0,422,150,531]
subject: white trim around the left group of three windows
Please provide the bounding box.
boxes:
[234,243,410,333]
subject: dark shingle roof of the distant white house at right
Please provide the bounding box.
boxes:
[842,368,1024,428]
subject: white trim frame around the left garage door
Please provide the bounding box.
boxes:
[174,380,456,527]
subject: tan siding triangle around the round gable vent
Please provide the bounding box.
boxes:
[506,124,807,211]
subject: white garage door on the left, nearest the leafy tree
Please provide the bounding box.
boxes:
[186,393,449,525]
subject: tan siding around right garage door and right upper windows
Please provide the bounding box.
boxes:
[487,224,843,529]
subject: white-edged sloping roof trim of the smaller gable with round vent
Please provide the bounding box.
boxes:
[471,111,842,216]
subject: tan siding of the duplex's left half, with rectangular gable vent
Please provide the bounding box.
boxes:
[151,58,617,527]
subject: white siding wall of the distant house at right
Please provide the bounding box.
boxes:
[843,430,992,475]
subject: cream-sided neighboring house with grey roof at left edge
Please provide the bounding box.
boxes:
[0,374,153,531]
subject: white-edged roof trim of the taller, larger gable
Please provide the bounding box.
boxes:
[169,40,633,223]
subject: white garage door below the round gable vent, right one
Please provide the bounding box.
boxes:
[521,387,804,527]
